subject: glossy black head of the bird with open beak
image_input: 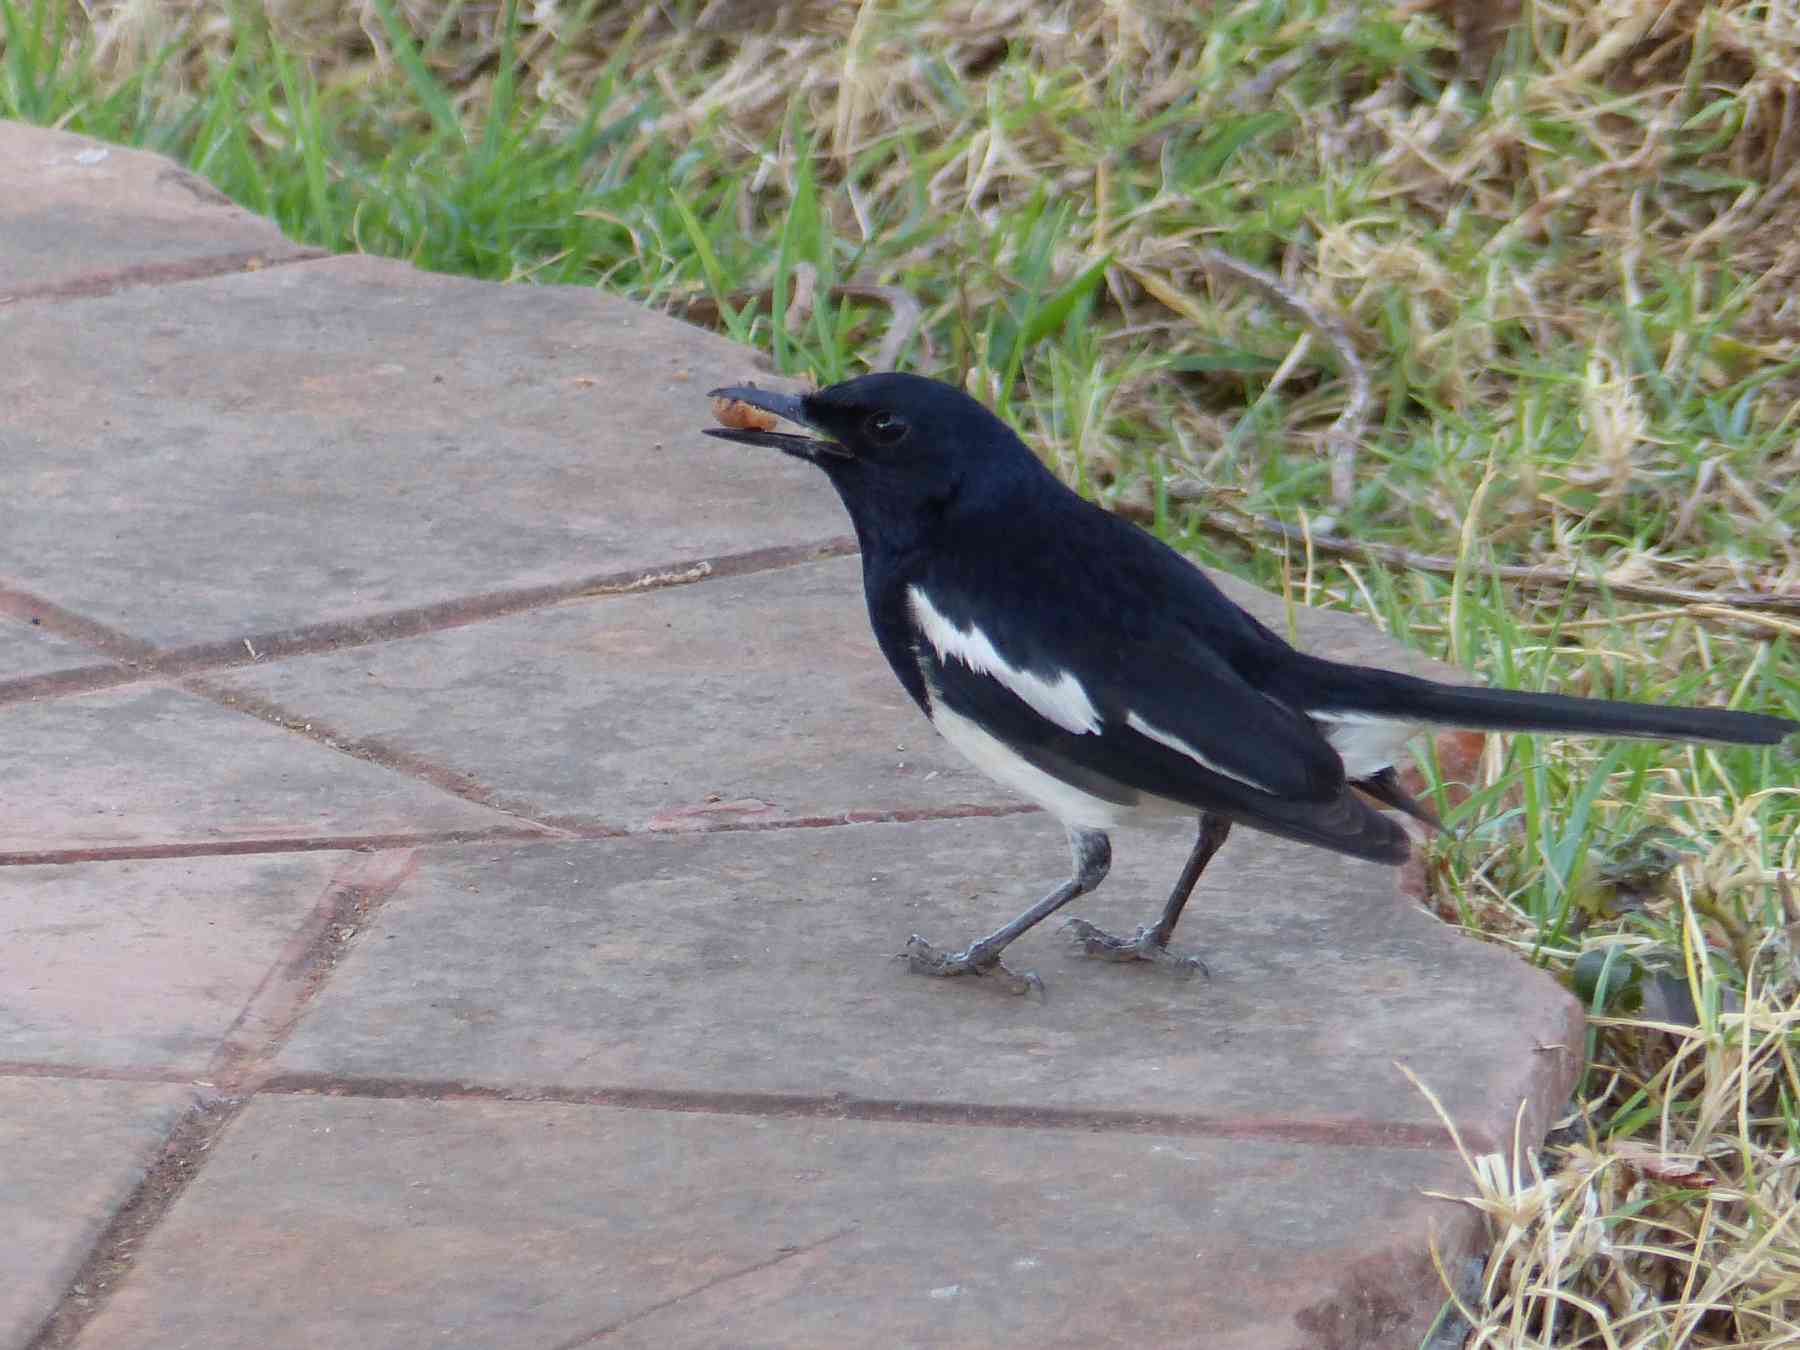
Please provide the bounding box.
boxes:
[706,373,1046,518]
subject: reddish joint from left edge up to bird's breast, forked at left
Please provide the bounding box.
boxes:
[0,535,857,706]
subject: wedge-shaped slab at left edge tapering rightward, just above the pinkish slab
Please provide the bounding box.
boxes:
[0,686,520,856]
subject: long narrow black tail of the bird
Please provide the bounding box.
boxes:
[1282,657,1800,745]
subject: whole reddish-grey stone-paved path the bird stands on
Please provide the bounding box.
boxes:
[0,124,1580,1350]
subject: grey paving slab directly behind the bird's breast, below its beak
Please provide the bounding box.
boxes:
[218,558,1453,830]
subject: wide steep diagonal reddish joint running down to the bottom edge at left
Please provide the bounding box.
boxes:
[25,850,418,1350]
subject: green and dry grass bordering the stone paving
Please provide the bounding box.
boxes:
[0,0,1800,1346]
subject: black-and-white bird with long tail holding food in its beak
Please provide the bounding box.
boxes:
[706,371,1800,992]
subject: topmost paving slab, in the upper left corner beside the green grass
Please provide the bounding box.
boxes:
[0,121,317,304]
